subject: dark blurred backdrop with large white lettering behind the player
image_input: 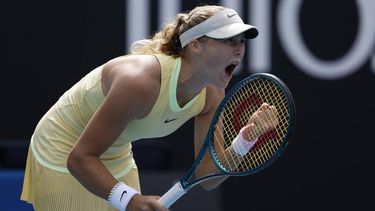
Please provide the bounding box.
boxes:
[0,0,375,211]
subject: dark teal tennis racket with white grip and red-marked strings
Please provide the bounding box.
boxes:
[159,73,296,208]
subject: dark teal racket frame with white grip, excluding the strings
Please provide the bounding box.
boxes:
[159,73,296,208]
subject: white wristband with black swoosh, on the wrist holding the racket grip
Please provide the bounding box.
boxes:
[108,182,139,211]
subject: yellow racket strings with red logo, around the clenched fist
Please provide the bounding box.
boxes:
[214,79,289,172]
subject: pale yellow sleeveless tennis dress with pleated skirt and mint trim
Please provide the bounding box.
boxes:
[21,54,206,211]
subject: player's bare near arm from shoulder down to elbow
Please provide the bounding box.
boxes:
[75,55,160,157]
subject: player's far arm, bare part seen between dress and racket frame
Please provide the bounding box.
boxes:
[194,86,225,156]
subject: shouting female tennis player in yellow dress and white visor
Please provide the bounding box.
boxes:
[21,5,274,211]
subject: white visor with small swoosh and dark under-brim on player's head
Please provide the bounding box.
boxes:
[180,9,258,48]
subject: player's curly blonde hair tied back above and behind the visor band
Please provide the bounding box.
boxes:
[130,5,224,57]
